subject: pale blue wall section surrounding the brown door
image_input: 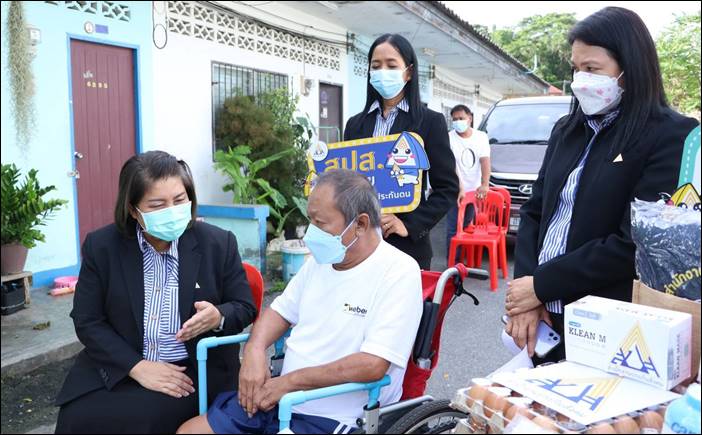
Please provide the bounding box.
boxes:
[0,1,153,286]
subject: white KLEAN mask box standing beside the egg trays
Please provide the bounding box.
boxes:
[564,296,692,390]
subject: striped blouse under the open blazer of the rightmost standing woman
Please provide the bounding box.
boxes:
[539,110,619,314]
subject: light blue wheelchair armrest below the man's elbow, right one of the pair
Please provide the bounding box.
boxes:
[278,375,390,431]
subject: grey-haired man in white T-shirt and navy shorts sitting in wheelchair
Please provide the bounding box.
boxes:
[178,169,422,433]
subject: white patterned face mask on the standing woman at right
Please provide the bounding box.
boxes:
[570,71,624,115]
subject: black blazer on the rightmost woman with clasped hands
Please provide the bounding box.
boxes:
[514,109,698,304]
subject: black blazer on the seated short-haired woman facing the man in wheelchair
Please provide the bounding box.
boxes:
[56,222,256,406]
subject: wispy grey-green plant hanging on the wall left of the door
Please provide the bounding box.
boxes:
[5,1,34,146]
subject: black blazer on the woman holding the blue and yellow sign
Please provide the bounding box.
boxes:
[344,107,458,269]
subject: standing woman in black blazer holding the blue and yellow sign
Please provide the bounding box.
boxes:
[344,34,458,270]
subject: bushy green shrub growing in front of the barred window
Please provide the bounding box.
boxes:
[215,89,314,234]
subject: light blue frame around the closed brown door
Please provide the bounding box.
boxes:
[66,33,143,260]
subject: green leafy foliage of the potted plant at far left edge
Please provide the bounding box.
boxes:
[0,164,68,249]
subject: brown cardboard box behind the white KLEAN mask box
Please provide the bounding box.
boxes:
[632,280,702,384]
